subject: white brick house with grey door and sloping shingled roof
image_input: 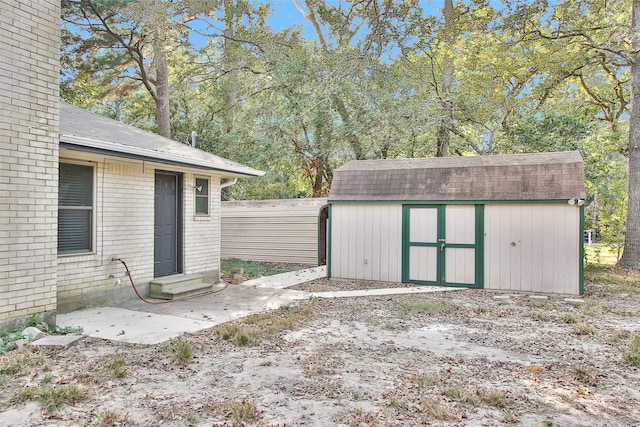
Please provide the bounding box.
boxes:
[0,0,262,328]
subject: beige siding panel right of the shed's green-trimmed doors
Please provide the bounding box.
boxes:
[484,204,581,294]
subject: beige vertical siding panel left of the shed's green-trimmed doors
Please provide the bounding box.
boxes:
[331,204,402,282]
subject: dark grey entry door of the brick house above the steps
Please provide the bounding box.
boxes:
[153,171,182,277]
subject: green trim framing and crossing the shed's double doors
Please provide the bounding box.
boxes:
[402,202,484,288]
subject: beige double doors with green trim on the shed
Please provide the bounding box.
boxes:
[402,205,484,288]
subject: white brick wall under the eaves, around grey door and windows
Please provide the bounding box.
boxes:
[58,150,220,312]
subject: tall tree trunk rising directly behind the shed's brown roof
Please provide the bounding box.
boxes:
[436,0,453,157]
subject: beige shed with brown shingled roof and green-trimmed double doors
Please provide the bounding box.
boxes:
[328,151,586,295]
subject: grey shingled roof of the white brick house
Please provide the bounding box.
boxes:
[60,102,264,177]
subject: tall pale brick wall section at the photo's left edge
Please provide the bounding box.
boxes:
[0,0,60,327]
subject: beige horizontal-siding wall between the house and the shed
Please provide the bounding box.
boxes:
[220,206,320,265]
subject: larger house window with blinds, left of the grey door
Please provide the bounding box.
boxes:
[58,163,93,255]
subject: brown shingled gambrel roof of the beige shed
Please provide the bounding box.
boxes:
[329,151,586,201]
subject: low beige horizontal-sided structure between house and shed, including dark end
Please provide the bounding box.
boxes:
[220,198,328,265]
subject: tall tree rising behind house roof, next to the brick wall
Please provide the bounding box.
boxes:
[62,0,202,137]
